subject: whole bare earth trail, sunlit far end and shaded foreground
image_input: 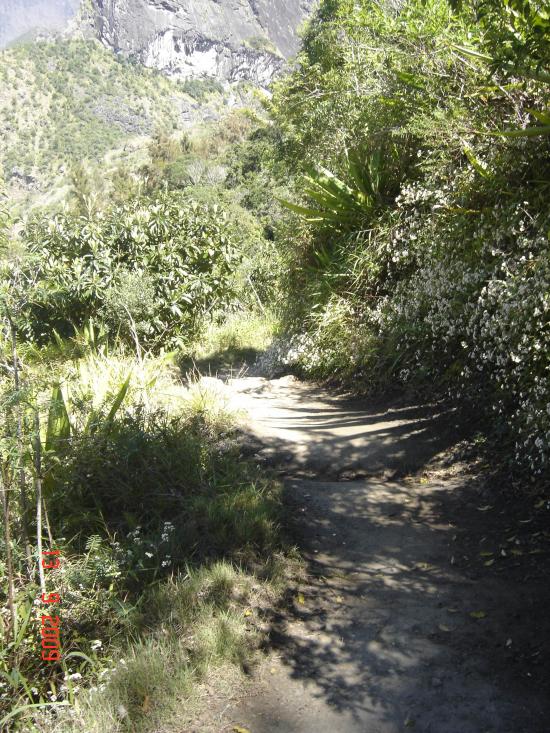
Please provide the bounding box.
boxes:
[200,377,550,733]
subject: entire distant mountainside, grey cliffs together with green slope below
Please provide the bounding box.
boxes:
[0,0,314,213]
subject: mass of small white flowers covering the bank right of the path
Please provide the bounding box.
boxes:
[280,185,550,474]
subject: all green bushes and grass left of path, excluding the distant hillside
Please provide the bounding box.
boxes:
[0,86,282,733]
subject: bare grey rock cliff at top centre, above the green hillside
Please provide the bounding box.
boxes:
[88,0,315,86]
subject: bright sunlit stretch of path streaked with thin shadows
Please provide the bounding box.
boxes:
[226,377,464,478]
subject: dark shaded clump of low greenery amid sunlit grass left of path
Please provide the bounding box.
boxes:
[50,406,282,560]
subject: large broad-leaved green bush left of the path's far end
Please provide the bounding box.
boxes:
[21,195,242,347]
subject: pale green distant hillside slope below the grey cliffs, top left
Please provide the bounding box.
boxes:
[0,40,230,210]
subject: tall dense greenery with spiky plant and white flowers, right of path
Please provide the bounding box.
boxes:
[269,0,550,472]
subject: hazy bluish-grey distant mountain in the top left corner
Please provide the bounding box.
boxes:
[0,0,79,48]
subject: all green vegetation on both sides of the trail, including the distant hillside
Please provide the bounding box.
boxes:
[0,0,550,733]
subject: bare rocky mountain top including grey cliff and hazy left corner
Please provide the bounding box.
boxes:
[0,0,317,83]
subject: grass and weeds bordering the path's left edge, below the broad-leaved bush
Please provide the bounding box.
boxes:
[0,344,288,733]
